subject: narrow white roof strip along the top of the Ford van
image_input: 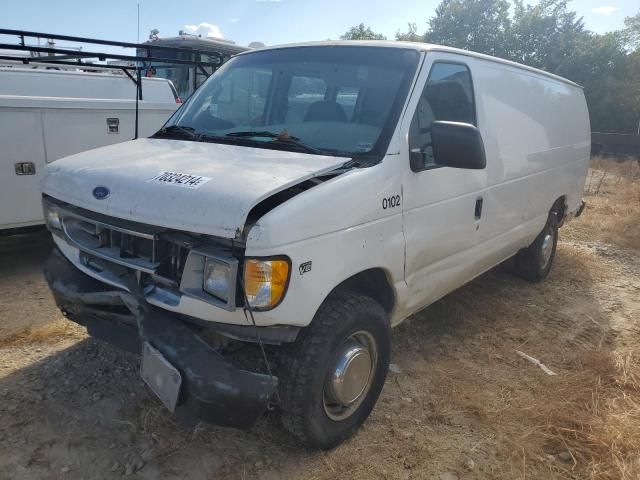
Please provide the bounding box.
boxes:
[239,40,582,88]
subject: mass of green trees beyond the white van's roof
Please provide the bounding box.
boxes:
[425,0,640,132]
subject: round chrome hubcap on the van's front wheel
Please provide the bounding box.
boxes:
[322,331,378,420]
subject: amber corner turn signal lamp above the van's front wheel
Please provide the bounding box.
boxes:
[244,258,289,310]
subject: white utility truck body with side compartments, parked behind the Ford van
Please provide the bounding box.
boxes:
[0,67,178,231]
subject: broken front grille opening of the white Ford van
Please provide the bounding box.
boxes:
[62,212,189,285]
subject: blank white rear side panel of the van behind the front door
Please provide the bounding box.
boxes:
[472,60,591,263]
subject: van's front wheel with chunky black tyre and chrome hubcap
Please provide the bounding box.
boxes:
[280,293,391,450]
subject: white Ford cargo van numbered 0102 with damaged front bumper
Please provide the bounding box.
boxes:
[43,42,590,448]
